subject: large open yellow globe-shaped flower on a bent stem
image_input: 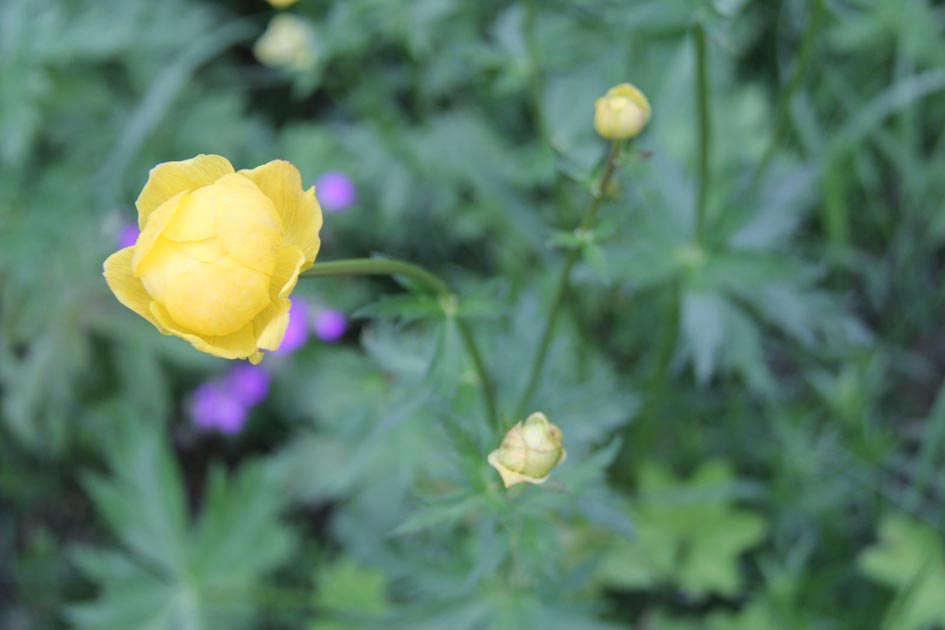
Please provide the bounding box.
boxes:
[105,155,322,363]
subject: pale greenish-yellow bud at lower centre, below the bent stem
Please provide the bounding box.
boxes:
[489,413,567,488]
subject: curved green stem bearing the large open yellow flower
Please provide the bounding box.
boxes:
[300,258,503,432]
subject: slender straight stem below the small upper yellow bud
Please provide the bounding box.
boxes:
[516,141,622,417]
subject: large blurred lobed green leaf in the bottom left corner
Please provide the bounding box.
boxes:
[67,425,293,630]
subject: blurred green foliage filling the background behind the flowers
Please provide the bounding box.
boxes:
[0,0,945,630]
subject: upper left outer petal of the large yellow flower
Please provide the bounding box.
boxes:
[135,154,233,230]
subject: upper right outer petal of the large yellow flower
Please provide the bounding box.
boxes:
[240,160,322,269]
